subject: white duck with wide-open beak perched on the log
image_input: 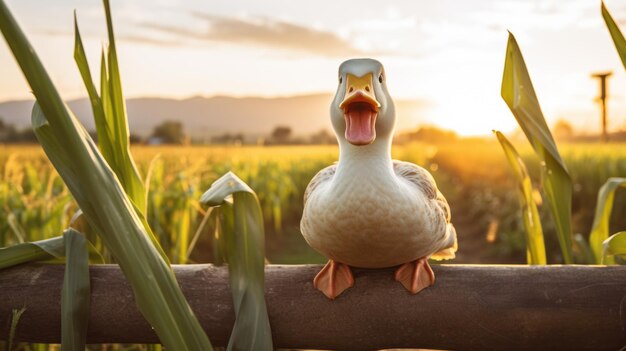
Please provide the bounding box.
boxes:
[300,58,458,299]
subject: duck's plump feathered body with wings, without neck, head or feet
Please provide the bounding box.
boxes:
[301,153,456,268]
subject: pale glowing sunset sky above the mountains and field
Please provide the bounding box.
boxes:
[0,0,626,135]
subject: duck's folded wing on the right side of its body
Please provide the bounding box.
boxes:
[393,160,458,260]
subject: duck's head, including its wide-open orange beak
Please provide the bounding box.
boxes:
[330,59,396,146]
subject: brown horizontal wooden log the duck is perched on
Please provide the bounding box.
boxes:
[0,264,626,350]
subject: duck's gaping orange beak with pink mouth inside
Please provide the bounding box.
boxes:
[339,73,380,145]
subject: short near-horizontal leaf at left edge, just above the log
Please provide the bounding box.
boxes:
[0,236,65,269]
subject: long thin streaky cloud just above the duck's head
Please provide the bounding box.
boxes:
[141,12,371,57]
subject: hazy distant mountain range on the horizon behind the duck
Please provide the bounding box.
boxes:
[0,94,427,139]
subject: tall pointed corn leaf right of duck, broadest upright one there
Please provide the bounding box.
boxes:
[501,33,573,264]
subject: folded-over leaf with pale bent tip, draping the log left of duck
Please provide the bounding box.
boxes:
[200,172,273,350]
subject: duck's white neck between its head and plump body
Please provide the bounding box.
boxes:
[337,137,393,177]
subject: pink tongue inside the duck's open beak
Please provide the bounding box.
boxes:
[344,103,378,145]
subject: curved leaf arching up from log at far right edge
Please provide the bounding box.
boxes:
[589,178,626,264]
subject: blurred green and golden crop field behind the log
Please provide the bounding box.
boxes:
[0,137,626,264]
